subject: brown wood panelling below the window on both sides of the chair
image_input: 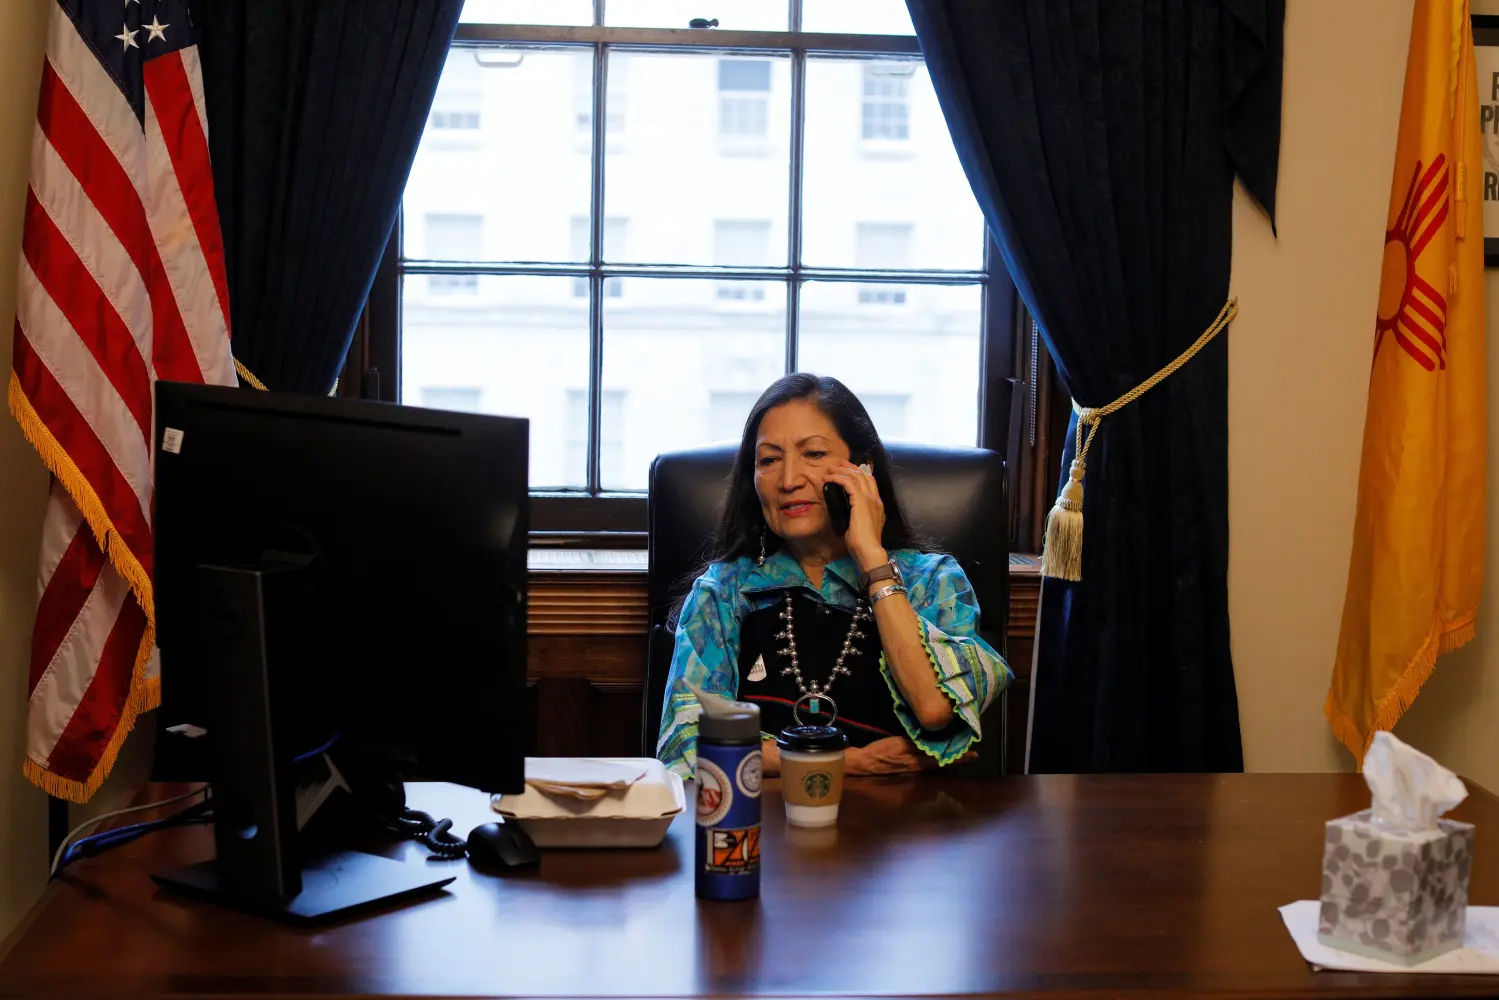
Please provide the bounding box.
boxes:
[526,552,1040,774]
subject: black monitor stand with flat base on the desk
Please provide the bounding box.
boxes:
[151,565,454,922]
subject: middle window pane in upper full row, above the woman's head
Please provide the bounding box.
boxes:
[605,52,791,265]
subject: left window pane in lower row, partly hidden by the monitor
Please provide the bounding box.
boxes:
[400,274,588,489]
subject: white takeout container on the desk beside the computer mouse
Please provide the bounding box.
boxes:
[490,757,687,847]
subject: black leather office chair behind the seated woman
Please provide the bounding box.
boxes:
[640,444,1010,774]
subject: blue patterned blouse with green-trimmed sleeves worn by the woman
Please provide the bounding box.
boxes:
[657,549,1013,778]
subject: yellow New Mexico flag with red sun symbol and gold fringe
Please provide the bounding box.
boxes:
[1324,0,1486,765]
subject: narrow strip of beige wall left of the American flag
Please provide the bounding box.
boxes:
[0,0,46,937]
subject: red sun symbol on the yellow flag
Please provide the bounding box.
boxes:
[1375,154,1448,372]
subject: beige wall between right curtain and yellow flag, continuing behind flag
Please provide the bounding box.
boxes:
[1229,0,1499,789]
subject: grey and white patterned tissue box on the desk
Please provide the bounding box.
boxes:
[1318,810,1474,966]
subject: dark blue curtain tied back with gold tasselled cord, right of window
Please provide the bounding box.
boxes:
[908,0,1285,772]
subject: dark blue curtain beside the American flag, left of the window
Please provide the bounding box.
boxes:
[195,0,463,393]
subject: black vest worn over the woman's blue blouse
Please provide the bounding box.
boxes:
[739,591,905,747]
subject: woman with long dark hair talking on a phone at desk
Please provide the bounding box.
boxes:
[657,373,1012,777]
